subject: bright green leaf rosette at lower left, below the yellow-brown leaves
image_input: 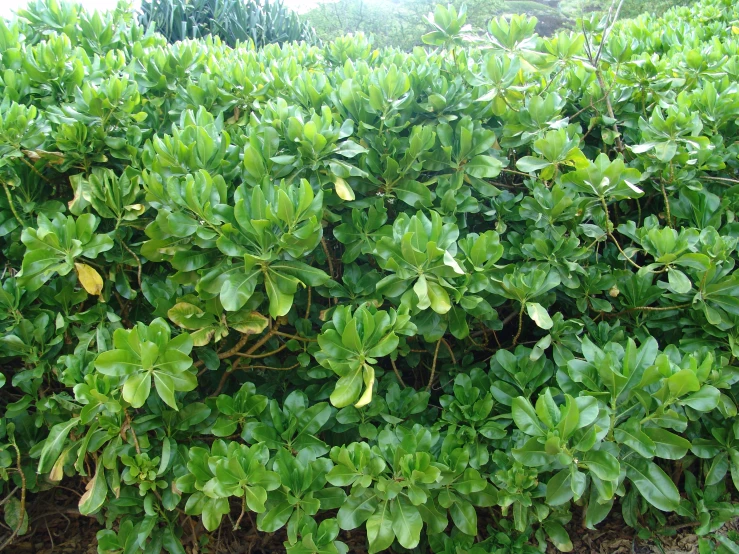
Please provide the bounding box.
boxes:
[95,318,198,410]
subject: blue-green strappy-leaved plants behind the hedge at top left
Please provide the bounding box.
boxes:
[139,0,316,47]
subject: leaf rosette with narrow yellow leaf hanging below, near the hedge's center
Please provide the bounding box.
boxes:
[315,304,415,408]
